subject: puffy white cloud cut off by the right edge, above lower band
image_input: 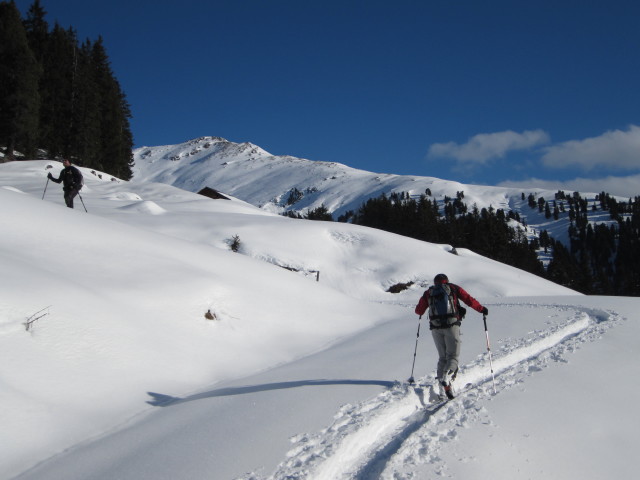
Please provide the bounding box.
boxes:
[542,125,640,170]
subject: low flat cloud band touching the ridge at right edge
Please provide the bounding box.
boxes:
[498,174,640,198]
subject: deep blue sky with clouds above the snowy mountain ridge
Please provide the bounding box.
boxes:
[16,0,640,196]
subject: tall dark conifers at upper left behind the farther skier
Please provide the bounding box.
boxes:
[0,0,133,180]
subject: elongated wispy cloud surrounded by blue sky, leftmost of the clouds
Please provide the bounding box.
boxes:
[427,130,549,163]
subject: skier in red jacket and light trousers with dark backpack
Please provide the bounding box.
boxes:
[415,273,489,398]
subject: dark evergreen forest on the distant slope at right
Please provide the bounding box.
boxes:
[302,188,640,296]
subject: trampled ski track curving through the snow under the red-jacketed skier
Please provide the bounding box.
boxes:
[240,304,622,480]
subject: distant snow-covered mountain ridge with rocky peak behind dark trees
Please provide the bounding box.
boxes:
[133,137,555,218]
